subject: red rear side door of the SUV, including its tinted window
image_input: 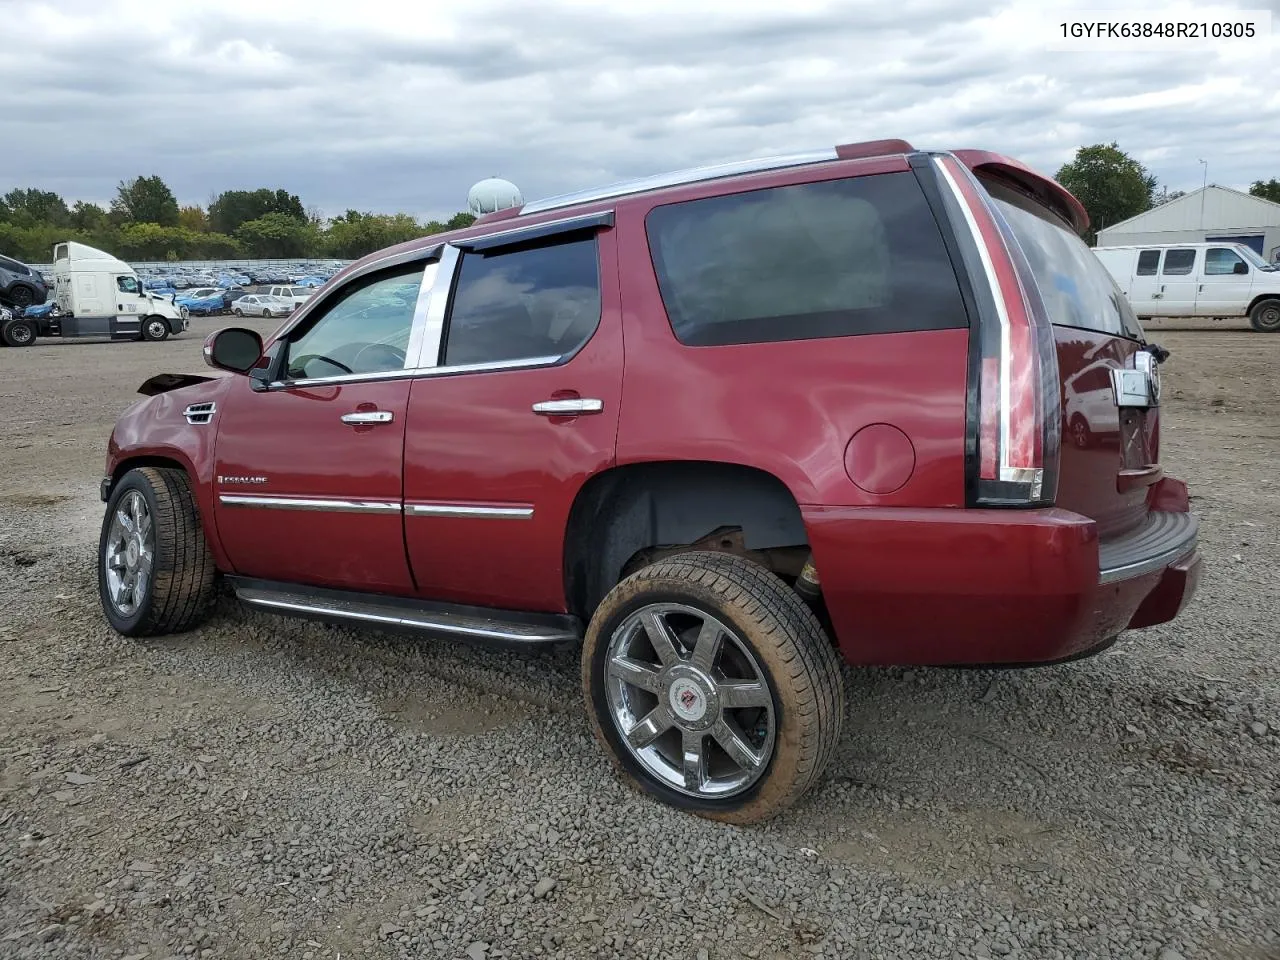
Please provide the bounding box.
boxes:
[404,215,622,612]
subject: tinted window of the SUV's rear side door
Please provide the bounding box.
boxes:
[443,234,600,366]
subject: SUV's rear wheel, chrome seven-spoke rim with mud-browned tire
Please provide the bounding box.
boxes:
[582,553,844,824]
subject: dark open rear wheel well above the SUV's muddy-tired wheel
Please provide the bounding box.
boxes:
[564,461,808,620]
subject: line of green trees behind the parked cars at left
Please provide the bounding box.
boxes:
[0,175,475,264]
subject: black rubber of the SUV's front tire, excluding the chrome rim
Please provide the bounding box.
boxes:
[97,467,218,636]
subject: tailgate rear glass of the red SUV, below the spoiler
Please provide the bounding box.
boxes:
[986,183,1142,339]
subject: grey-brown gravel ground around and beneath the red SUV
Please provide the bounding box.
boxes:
[0,320,1280,960]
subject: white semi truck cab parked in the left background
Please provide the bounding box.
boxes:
[0,241,188,347]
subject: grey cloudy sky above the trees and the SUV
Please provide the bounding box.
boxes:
[0,0,1280,215]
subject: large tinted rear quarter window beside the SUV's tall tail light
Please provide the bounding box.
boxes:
[646,173,968,347]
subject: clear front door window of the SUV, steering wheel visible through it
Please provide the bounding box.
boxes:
[284,261,438,380]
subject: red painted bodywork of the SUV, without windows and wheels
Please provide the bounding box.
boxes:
[99,141,1201,664]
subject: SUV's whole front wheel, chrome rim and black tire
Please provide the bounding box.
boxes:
[97,467,216,636]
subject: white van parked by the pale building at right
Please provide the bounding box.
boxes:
[1093,243,1280,333]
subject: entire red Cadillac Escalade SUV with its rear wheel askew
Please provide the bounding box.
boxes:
[99,141,1201,823]
